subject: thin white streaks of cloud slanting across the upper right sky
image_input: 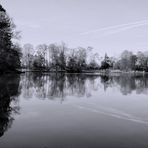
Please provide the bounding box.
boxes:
[80,20,148,35]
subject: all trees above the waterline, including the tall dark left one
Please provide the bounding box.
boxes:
[0,5,148,73]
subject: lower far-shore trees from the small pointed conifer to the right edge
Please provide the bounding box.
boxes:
[100,50,148,72]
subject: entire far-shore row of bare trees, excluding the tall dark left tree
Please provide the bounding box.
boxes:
[22,43,148,72]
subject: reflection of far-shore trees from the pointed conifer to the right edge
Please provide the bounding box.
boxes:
[101,74,148,95]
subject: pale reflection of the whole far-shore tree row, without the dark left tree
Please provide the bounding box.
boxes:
[21,73,148,101]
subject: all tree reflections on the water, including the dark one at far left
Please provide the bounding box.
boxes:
[0,73,148,139]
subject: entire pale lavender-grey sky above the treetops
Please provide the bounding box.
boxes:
[1,0,148,55]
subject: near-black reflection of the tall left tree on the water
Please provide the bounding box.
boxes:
[0,76,20,137]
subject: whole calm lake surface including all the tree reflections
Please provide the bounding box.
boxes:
[0,74,148,148]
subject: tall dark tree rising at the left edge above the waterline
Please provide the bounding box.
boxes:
[0,5,20,72]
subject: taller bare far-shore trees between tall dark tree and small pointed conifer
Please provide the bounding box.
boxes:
[22,43,99,72]
